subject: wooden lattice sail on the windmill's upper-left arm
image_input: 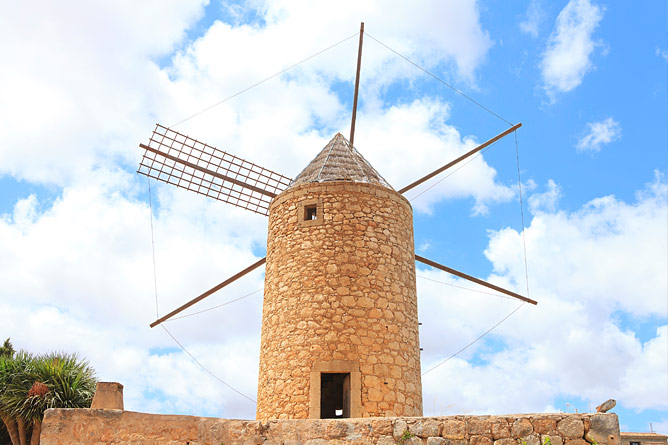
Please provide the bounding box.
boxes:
[137,124,292,215]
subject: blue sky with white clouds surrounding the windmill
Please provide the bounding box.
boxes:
[0,0,668,433]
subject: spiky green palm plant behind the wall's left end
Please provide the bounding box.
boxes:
[0,352,97,445]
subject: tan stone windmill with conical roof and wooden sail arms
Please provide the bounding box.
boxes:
[138,24,536,419]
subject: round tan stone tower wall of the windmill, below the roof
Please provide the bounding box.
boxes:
[257,181,422,419]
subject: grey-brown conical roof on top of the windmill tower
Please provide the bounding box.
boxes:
[290,133,394,190]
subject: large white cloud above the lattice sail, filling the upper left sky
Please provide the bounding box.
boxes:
[0,1,492,186]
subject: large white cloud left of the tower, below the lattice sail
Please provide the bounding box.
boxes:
[0,174,266,417]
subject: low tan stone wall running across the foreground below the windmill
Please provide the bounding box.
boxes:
[41,409,621,445]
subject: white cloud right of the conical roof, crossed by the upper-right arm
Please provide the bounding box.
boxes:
[355,99,515,214]
